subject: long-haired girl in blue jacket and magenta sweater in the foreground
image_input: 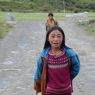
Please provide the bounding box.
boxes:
[34,26,80,95]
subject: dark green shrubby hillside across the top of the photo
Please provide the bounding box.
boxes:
[0,0,95,12]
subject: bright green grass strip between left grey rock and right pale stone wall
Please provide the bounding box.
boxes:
[13,13,64,21]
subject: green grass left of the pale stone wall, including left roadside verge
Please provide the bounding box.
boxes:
[0,12,64,38]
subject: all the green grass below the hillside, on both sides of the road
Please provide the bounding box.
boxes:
[0,12,95,38]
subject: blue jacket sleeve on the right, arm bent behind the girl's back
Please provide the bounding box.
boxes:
[71,54,80,79]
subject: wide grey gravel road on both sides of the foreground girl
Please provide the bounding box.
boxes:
[0,19,95,95]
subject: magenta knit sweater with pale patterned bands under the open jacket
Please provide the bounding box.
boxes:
[46,52,72,94]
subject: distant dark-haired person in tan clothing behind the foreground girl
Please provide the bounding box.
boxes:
[46,13,58,31]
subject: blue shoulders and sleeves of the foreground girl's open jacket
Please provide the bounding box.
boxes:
[34,47,80,81]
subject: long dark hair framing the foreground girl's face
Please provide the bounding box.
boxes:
[43,26,66,49]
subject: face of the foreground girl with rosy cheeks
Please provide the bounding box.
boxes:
[48,30,63,49]
